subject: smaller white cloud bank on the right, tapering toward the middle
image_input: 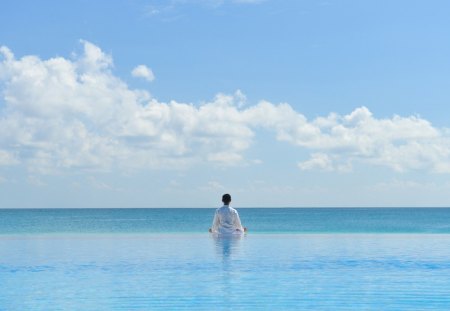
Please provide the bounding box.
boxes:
[242,101,450,173]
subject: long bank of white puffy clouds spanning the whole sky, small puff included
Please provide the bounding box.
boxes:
[0,41,450,174]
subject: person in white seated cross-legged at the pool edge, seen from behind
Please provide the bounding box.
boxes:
[209,193,247,234]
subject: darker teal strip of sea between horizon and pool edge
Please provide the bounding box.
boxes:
[0,207,450,234]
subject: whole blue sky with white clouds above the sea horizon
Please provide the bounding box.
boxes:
[0,0,450,207]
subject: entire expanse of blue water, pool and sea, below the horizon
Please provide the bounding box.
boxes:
[0,208,450,310]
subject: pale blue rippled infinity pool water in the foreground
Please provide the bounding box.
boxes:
[0,233,450,310]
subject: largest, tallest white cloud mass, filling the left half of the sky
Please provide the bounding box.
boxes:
[0,41,253,172]
